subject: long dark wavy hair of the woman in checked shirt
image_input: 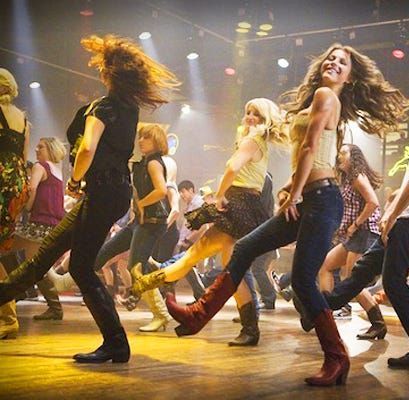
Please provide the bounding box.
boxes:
[336,144,383,189]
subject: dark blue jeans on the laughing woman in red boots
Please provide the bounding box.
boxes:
[228,186,343,319]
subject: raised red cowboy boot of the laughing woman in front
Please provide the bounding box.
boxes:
[166,271,237,336]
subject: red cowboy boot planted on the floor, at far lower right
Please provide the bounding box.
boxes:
[305,310,349,386]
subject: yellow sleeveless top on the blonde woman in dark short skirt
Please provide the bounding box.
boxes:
[232,135,268,192]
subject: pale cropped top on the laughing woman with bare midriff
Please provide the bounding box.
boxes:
[290,114,337,171]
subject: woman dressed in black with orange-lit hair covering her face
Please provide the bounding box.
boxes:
[0,35,178,363]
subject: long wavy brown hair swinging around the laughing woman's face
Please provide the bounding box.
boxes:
[282,43,409,147]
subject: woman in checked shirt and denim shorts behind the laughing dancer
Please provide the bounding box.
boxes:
[319,144,386,339]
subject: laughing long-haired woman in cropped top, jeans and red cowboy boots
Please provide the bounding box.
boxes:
[167,44,409,386]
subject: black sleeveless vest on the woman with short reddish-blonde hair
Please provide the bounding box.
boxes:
[132,153,170,223]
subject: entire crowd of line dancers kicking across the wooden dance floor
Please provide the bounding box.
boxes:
[0,35,409,386]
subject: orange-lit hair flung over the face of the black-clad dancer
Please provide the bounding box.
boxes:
[81,35,180,109]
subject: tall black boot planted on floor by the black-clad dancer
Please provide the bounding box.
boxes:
[73,284,130,363]
